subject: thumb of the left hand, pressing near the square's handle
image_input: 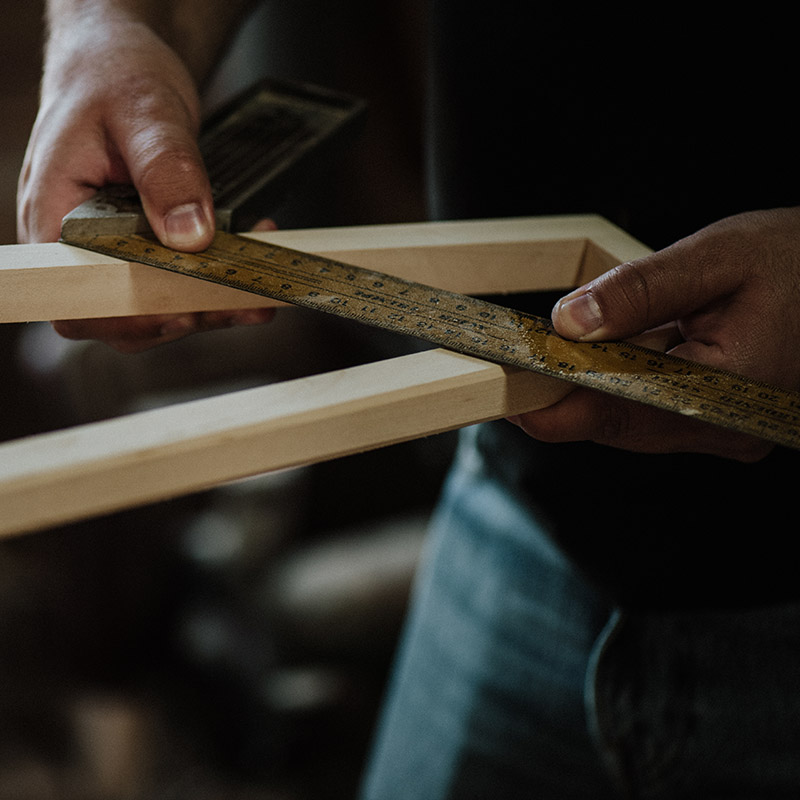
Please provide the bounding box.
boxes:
[111,98,215,251]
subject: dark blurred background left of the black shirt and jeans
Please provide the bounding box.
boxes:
[0,0,453,800]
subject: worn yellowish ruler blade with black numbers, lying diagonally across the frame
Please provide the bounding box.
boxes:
[66,232,800,449]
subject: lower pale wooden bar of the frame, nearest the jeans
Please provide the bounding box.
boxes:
[0,350,568,536]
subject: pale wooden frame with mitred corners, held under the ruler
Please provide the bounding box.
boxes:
[0,216,649,535]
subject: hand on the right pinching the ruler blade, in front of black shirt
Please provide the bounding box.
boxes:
[513,208,800,461]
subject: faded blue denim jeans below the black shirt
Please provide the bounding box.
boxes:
[362,430,800,800]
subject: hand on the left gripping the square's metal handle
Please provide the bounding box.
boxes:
[18,4,272,352]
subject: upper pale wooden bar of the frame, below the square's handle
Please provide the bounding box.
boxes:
[0,216,646,322]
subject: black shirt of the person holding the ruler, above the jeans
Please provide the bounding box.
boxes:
[429,0,800,608]
